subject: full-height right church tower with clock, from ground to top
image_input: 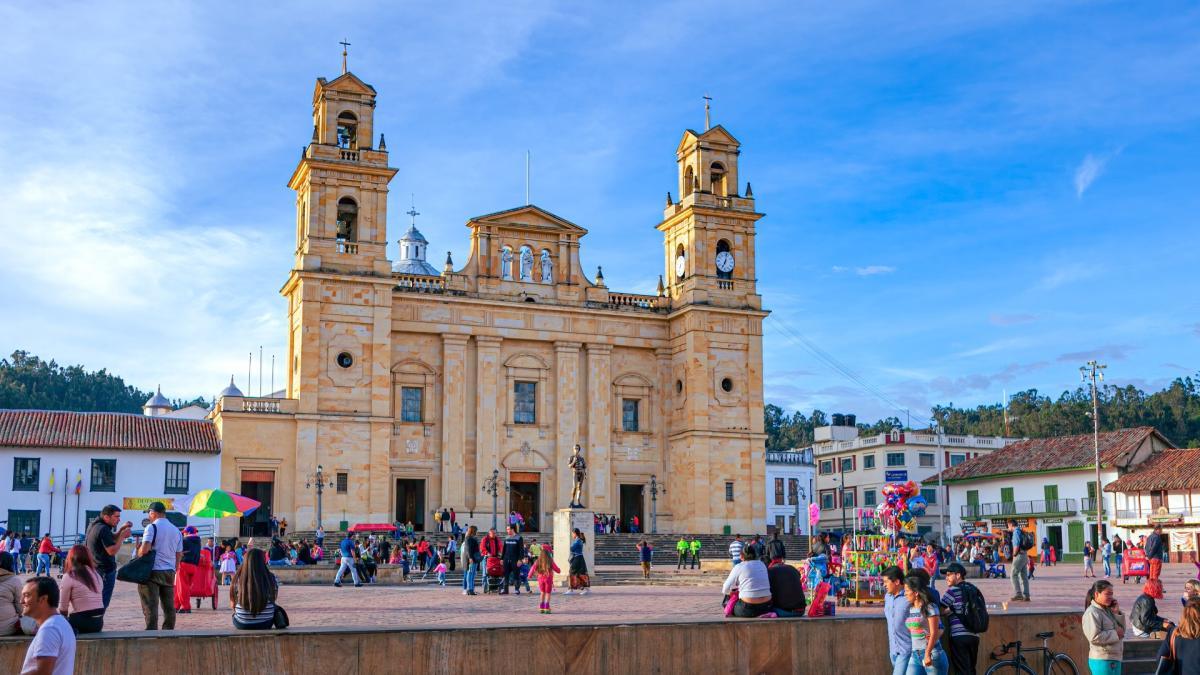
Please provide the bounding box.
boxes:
[656,119,767,531]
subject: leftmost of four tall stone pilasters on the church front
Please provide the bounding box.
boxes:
[440,333,469,509]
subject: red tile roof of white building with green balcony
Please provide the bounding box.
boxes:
[925,426,1174,482]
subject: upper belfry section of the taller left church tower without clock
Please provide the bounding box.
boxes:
[288,72,396,276]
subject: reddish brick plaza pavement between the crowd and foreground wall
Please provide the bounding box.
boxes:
[88,563,1196,631]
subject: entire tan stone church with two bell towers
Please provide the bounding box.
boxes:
[214,65,767,534]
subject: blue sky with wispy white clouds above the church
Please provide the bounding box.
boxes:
[0,0,1200,420]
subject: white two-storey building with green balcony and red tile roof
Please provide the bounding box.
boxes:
[942,426,1175,560]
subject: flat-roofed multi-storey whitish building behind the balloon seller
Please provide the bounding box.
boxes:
[812,416,1016,534]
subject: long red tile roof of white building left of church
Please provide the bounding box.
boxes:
[0,410,221,454]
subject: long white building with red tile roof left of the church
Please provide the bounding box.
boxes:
[0,408,221,540]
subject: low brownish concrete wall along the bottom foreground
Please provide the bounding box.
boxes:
[0,613,1087,675]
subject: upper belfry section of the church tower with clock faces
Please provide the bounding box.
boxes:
[658,125,762,309]
